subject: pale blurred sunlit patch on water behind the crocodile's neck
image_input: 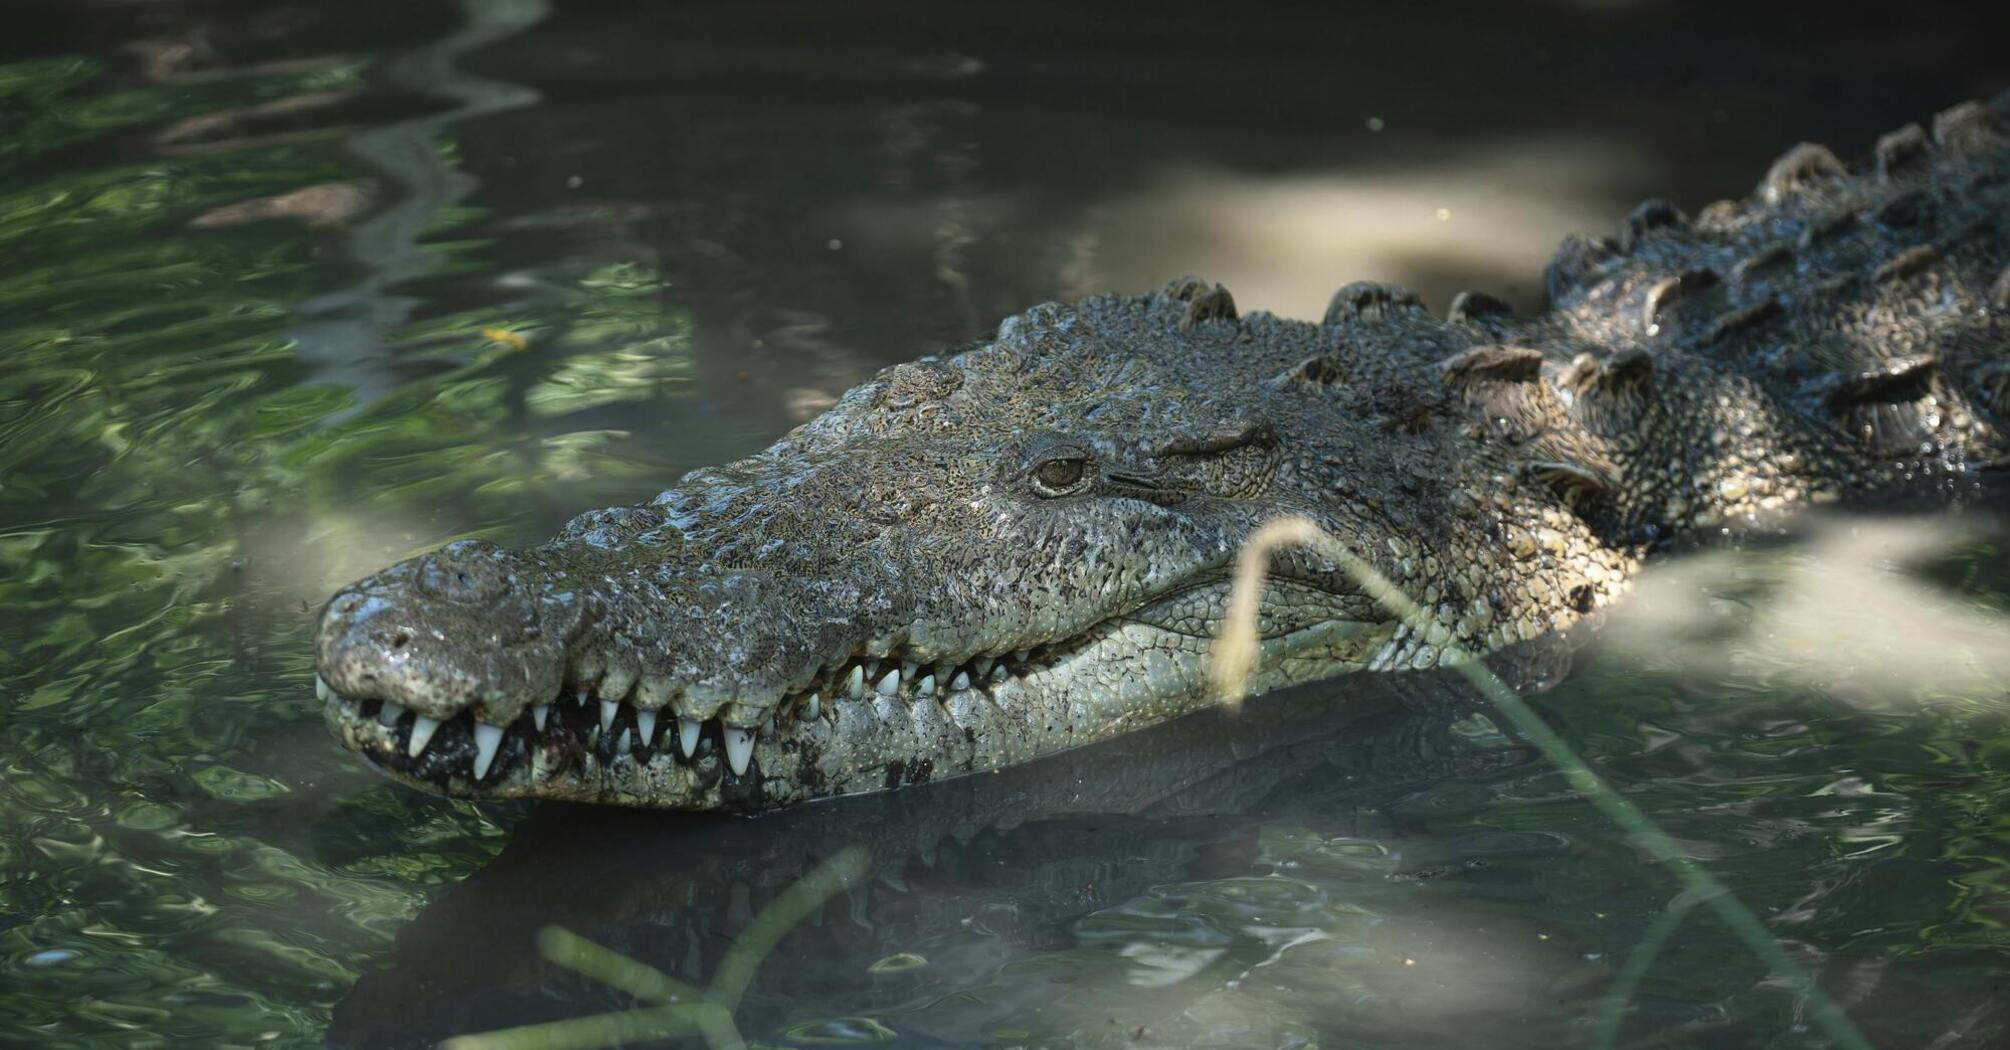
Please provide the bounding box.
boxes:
[1067,141,1644,320]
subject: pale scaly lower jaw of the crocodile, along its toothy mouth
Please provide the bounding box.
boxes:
[318,607,1393,811]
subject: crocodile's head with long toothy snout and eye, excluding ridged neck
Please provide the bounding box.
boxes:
[318,296,1599,809]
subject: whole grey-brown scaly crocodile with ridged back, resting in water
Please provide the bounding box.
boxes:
[316,93,2010,811]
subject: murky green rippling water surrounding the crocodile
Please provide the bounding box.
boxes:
[0,0,2010,1048]
